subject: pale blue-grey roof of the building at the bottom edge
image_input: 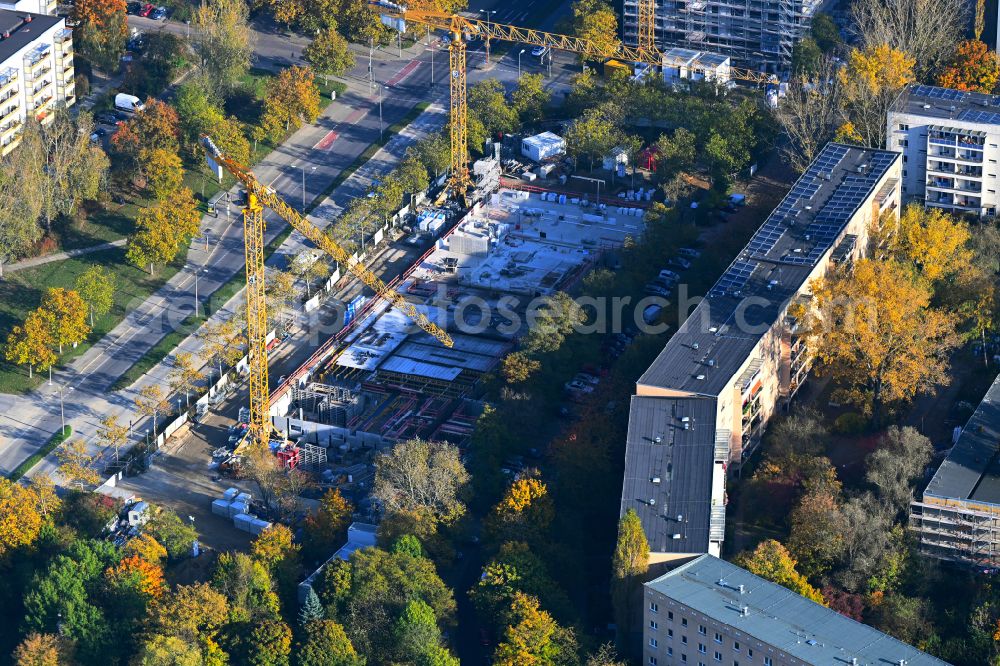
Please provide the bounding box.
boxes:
[645,555,947,666]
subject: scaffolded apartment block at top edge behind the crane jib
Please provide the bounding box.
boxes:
[622,0,822,73]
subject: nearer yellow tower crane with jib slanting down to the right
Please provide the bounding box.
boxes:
[202,136,453,445]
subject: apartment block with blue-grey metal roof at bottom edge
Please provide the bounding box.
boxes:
[642,555,947,666]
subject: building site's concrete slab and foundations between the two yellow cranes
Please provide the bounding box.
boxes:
[271,179,643,460]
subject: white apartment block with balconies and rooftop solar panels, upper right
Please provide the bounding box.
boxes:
[886,85,1000,215]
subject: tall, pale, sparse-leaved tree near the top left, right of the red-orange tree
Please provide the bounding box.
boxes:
[191,0,254,97]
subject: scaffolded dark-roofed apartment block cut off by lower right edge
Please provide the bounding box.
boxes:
[910,376,1000,568]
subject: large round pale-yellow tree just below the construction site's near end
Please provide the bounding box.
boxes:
[372,439,469,534]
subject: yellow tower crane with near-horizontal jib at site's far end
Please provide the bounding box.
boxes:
[372,0,776,196]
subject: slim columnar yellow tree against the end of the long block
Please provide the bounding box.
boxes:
[611,509,649,645]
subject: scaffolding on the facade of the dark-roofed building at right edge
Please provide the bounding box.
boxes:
[910,501,1000,567]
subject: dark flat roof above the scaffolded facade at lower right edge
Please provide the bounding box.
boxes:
[924,368,1000,504]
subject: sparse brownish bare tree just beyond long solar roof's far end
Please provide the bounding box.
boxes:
[772,58,843,172]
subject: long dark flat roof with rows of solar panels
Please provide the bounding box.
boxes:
[638,143,899,396]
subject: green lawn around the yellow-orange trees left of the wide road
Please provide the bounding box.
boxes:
[0,247,187,393]
